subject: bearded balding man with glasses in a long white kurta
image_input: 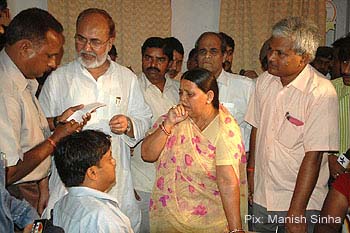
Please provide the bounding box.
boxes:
[39,8,151,232]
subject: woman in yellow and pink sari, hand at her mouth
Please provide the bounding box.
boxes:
[142,69,244,233]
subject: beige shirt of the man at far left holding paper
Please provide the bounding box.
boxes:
[0,49,50,183]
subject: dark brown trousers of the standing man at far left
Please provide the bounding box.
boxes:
[7,181,40,210]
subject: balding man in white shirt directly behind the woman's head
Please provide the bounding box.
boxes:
[196,32,255,151]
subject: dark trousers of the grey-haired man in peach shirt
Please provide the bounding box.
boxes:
[250,203,320,233]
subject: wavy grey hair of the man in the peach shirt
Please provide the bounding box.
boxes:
[272,17,320,61]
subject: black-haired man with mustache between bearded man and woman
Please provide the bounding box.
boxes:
[131,37,179,233]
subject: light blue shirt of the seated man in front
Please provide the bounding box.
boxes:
[53,186,133,233]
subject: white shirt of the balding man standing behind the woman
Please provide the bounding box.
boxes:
[217,70,255,151]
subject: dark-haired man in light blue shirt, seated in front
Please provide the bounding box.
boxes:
[53,130,133,233]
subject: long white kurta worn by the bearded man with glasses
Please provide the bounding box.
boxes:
[39,61,151,232]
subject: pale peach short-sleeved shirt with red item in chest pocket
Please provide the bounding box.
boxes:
[246,65,338,211]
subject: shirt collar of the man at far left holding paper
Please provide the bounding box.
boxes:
[0,49,38,95]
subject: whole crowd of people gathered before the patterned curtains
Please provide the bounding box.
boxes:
[0,3,350,233]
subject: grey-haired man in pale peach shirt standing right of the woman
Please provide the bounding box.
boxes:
[245,17,338,233]
